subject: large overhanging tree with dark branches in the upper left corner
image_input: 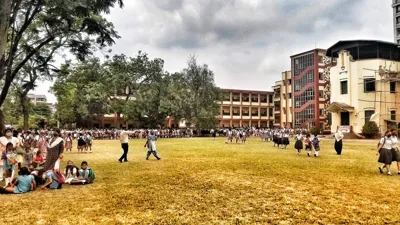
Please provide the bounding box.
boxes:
[0,0,123,133]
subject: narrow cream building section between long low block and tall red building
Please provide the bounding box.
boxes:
[273,71,293,128]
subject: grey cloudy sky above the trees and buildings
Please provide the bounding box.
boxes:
[37,0,393,101]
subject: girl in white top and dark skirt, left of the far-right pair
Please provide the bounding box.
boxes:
[378,131,393,176]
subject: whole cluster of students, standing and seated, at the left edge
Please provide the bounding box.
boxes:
[0,128,95,194]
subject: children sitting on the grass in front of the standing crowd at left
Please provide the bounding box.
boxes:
[0,161,95,194]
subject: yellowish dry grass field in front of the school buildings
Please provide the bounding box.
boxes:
[0,139,400,225]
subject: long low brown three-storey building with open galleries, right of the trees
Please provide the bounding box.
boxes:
[219,89,274,127]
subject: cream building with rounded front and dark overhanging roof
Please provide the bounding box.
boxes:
[326,40,400,133]
